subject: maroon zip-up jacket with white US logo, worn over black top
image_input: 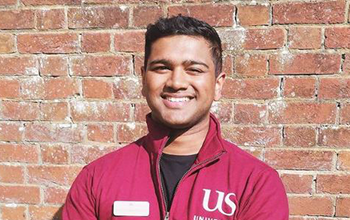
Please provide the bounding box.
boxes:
[62,115,288,220]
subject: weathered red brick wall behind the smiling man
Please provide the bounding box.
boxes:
[0,0,350,220]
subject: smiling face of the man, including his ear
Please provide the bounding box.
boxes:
[142,35,225,129]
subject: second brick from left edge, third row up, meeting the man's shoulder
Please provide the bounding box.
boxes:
[27,165,82,186]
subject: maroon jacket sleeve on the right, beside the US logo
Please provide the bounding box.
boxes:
[238,169,289,220]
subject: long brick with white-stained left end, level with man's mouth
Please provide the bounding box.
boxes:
[268,101,336,124]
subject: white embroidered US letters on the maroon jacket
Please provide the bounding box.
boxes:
[203,189,236,216]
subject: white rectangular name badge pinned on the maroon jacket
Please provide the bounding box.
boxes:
[113,201,149,216]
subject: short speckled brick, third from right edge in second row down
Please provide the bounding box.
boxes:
[243,28,286,50]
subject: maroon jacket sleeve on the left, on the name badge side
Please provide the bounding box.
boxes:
[62,168,97,220]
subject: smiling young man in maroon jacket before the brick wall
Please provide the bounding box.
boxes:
[63,15,288,220]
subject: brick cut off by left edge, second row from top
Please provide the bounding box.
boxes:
[0,10,35,30]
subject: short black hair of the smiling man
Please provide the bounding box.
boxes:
[144,14,222,76]
